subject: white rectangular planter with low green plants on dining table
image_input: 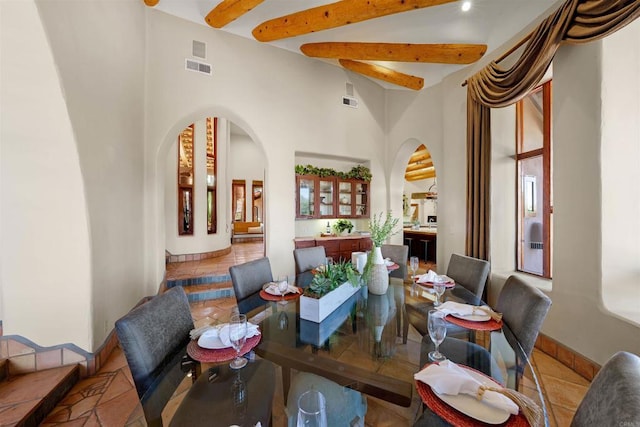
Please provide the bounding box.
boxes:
[300,261,360,323]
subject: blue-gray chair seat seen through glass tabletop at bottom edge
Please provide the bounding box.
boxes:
[285,372,367,427]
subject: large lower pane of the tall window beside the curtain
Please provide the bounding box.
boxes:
[518,156,544,275]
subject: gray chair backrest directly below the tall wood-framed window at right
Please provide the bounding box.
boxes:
[496,275,551,357]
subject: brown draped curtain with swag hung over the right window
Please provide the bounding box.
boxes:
[465,0,640,260]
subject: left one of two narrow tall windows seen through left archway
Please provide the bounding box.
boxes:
[178,124,194,236]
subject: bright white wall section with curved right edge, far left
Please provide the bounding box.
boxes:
[0,1,93,349]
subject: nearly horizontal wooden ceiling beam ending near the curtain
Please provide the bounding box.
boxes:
[300,42,487,64]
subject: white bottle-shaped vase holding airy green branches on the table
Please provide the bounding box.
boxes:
[364,211,399,295]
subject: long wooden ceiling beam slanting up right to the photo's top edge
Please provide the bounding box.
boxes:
[253,0,455,42]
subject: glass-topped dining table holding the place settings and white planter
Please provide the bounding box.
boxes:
[240,278,547,425]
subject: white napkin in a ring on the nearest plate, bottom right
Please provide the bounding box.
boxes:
[414,360,520,415]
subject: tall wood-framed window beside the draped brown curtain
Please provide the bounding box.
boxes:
[516,81,553,278]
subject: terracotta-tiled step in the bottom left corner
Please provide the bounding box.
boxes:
[0,365,80,427]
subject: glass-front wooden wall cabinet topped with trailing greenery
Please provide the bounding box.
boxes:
[296,175,369,219]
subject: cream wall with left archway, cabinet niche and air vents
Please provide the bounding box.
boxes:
[145,9,386,285]
